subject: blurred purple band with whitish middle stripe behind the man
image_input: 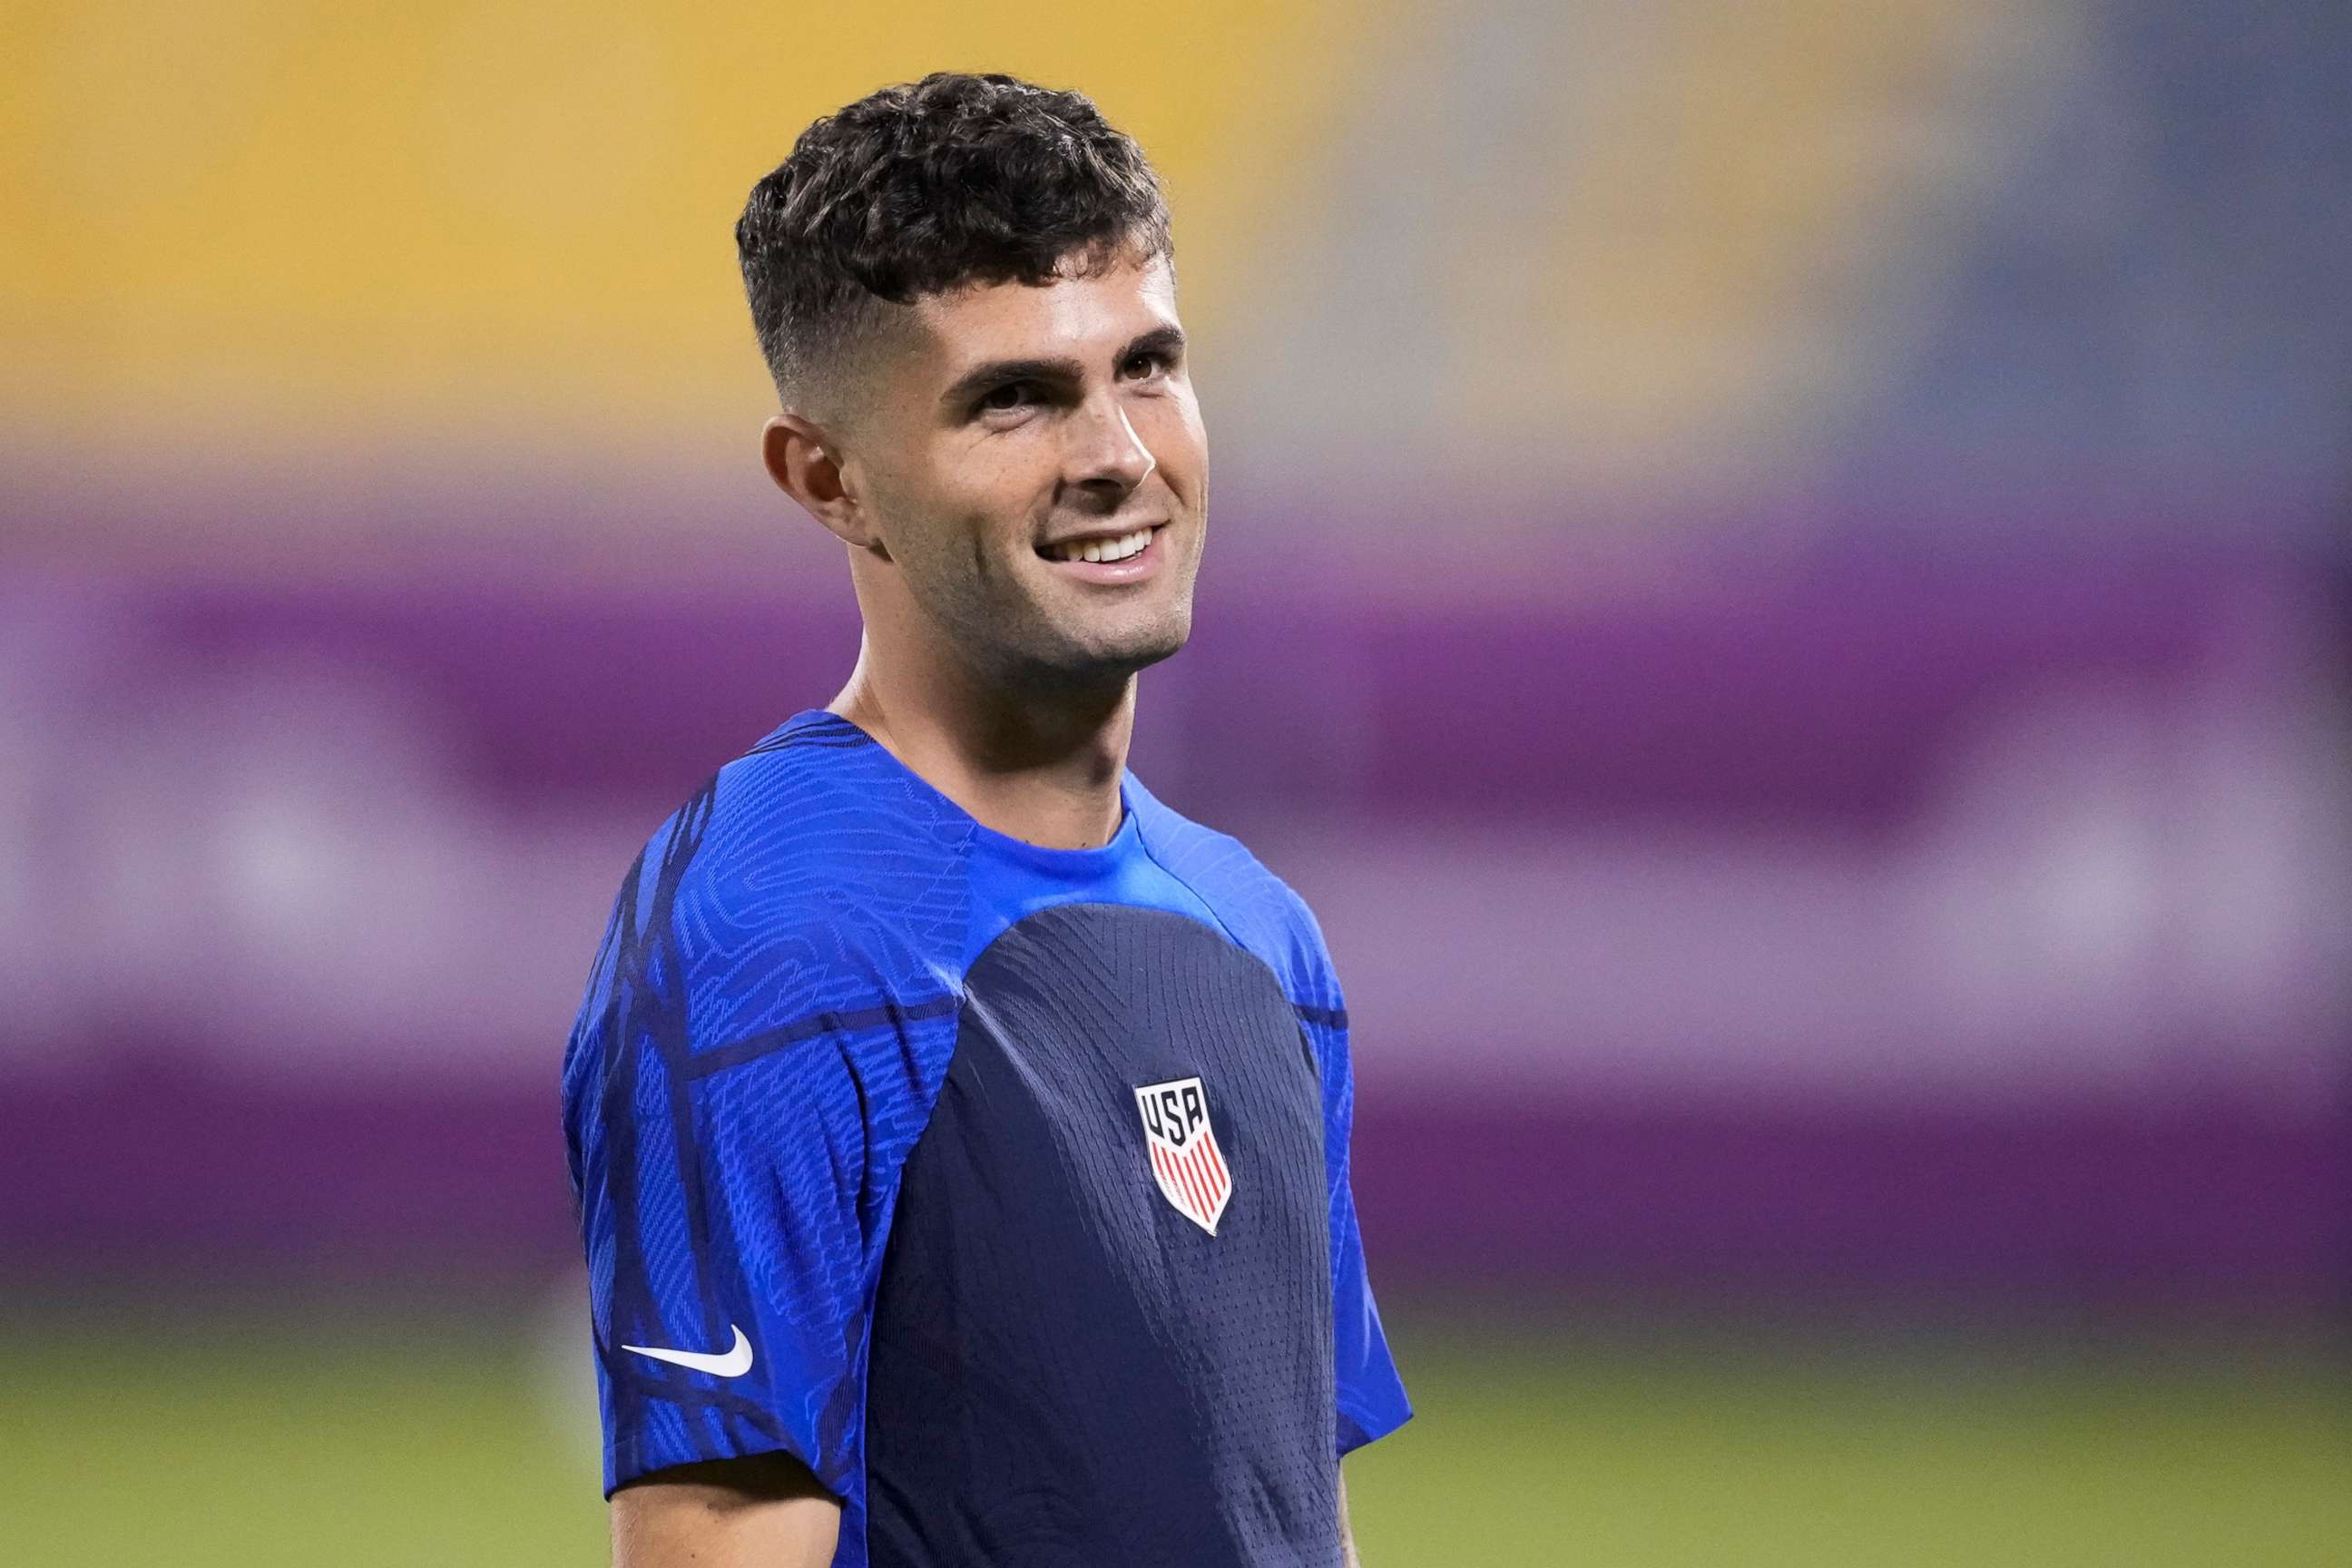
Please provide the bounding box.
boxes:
[0,545,2352,1314]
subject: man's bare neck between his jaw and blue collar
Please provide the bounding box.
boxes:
[828,644,1136,848]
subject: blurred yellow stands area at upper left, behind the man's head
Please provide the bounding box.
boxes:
[0,0,1383,461]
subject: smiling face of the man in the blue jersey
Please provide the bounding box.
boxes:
[858,259,1209,686]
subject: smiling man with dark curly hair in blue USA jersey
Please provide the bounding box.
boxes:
[564,75,1409,1568]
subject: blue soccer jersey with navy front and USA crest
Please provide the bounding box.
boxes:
[564,712,1409,1568]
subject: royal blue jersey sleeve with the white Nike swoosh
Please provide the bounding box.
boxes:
[564,823,877,1495]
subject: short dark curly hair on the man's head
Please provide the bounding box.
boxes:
[736,71,1173,407]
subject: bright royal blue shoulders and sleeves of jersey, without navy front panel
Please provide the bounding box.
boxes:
[564,712,1409,1568]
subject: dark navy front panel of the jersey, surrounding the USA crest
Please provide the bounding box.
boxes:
[867,903,1338,1568]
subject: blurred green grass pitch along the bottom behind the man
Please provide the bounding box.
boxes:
[0,1312,2352,1568]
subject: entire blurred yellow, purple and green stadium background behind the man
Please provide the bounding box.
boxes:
[0,0,2352,1568]
